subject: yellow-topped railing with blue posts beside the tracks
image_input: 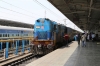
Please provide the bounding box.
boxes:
[0,37,33,59]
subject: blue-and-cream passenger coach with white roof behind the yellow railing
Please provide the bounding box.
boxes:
[0,26,33,50]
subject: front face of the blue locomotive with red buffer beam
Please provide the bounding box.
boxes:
[32,18,53,54]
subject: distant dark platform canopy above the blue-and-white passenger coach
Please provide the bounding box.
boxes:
[0,19,33,28]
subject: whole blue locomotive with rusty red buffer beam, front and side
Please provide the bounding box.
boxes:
[31,18,67,54]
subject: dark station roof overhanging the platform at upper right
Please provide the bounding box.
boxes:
[48,0,100,30]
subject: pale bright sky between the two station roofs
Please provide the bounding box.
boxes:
[0,0,82,32]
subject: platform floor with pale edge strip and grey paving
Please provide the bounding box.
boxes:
[26,41,100,66]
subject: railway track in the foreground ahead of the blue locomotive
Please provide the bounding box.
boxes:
[1,54,42,66]
